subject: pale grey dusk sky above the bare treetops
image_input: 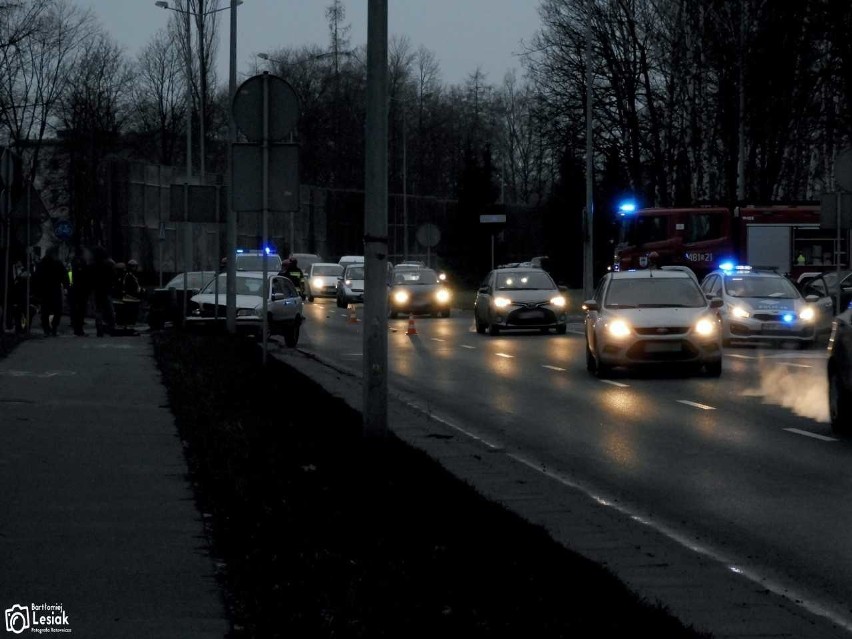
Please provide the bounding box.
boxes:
[83,0,539,84]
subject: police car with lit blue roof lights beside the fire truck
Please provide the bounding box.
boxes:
[701,263,831,346]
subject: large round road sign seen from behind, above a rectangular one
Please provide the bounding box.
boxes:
[231,73,299,142]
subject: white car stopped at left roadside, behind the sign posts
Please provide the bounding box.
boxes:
[187,271,305,346]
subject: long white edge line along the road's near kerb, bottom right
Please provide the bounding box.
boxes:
[506,453,852,630]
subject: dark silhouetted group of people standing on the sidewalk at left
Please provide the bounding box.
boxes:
[32,246,141,337]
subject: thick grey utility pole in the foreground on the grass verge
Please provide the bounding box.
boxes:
[363,0,388,437]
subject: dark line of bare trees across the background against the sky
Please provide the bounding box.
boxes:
[0,0,852,278]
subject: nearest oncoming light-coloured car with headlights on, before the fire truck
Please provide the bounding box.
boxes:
[583,267,722,377]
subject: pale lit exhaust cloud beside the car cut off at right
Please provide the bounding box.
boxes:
[741,360,829,423]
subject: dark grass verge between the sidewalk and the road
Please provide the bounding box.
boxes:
[153,332,701,639]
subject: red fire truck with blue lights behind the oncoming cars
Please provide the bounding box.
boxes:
[613,204,849,280]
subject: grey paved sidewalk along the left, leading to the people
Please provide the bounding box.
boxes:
[0,327,228,639]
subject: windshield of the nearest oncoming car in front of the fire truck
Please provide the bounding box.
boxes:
[604,277,707,308]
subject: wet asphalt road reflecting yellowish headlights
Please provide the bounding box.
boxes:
[300,300,852,627]
